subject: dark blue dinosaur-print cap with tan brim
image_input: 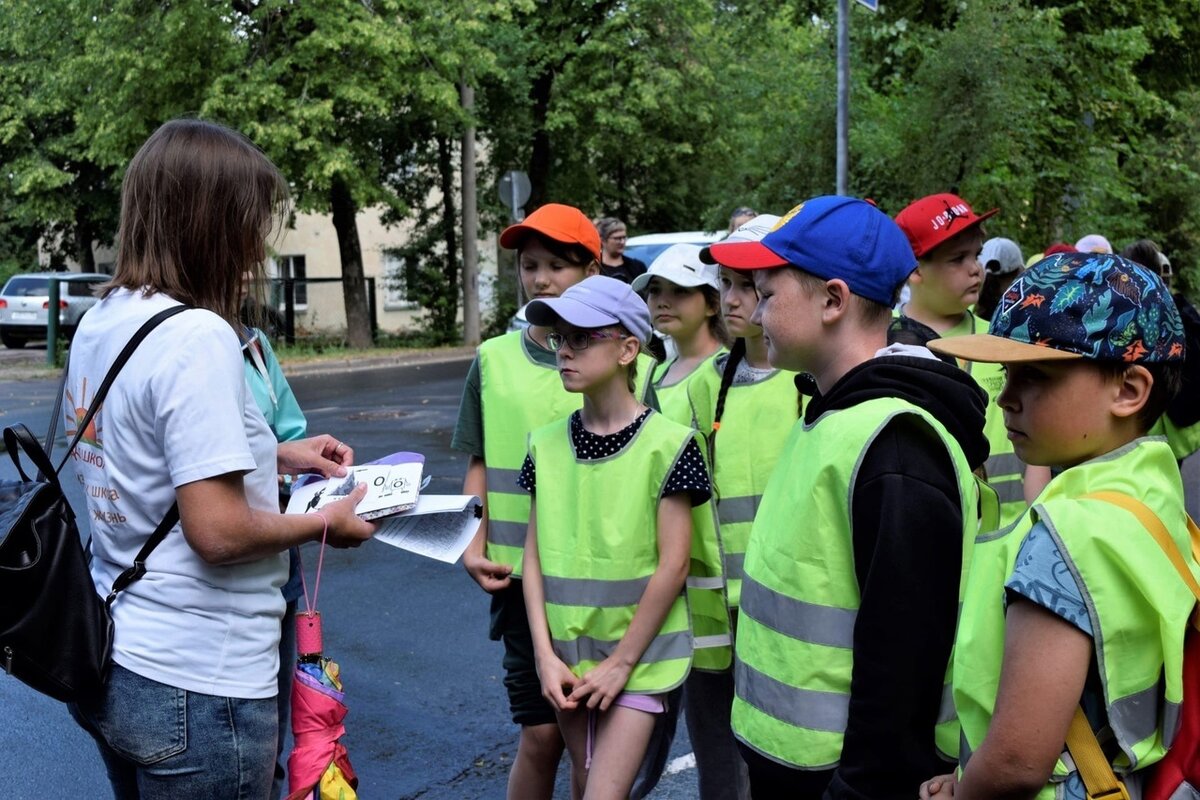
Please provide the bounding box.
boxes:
[929,253,1184,363]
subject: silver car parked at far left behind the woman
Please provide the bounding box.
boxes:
[0,272,109,349]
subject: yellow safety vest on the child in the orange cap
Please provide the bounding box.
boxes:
[479,331,654,578]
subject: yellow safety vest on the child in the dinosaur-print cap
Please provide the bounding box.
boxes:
[954,439,1200,798]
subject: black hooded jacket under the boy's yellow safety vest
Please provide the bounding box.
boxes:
[796,356,988,800]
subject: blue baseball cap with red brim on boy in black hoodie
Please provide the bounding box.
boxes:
[709,196,917,306]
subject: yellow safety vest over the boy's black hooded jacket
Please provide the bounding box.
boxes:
[718,398,978,769]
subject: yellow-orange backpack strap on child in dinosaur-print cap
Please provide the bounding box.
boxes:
[1067,492,1200,800]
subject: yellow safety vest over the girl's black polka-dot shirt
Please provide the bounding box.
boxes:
[529,413,694,692]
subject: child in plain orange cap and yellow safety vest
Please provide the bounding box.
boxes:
[451,203,654,800]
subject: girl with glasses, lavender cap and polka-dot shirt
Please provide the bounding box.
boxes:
[517,276,727,798]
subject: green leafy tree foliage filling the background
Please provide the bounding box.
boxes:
[0,0,1200,335]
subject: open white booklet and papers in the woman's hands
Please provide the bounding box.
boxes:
[287,452,484,564]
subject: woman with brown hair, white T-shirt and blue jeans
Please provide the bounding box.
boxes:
[66,120,374,799]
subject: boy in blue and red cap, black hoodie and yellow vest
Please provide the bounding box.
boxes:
[710,197,988,800]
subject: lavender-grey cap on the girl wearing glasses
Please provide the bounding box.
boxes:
[524,275,650,344]
